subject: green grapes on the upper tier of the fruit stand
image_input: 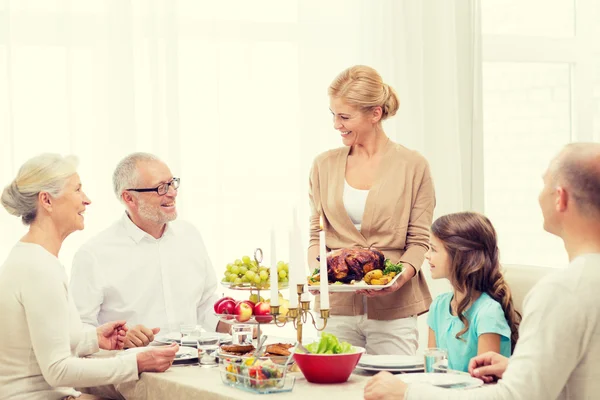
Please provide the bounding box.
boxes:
[222,256,289,288]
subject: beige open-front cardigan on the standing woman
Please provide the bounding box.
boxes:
[309,141,435,320]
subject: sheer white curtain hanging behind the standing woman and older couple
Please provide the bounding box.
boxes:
[0,0,480,284]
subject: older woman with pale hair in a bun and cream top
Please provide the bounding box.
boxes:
[0,154,178,399]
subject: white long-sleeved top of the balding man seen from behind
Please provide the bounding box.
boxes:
[400,254,600,400]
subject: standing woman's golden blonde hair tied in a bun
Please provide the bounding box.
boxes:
[327,65,400,121]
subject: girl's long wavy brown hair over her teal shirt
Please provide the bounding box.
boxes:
[431,212,521,350]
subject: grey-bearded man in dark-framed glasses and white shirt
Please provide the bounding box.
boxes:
[70,153,227,347]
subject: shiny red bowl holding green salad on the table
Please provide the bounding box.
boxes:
[294,346,365,383]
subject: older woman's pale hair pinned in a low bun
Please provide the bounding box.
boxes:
[0,153,78,225]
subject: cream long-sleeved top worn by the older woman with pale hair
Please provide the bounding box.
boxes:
[0,242,138,400]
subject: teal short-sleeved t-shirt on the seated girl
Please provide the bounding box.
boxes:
[427,292,511,372]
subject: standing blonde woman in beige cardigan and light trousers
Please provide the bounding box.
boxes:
[308,65,435,355]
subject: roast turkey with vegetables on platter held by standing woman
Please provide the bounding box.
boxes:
[308,248,404,293]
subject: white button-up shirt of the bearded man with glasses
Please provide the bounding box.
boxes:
[71,214,218,333]
